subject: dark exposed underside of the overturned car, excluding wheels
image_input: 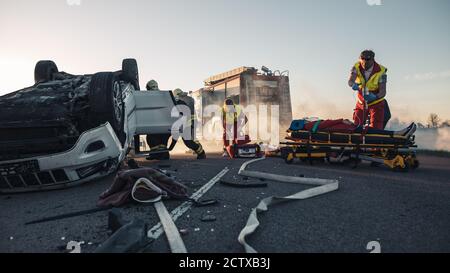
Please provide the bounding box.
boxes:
[0,73,92,161]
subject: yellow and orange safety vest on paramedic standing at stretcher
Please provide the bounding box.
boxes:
[355,62,387,106]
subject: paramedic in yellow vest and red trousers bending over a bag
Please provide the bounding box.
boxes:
[222,99,248,157]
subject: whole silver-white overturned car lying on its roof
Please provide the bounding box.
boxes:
[0,59,176,193]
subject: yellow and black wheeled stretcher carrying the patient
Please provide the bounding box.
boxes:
[280,122,419,171]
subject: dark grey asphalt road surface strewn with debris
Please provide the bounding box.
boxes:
[0,154,450,253]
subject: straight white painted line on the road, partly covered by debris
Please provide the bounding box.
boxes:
[147,168,229,240]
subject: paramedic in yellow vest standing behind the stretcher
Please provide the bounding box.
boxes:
[348,50,391,130]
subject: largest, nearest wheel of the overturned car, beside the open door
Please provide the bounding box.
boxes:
[89,72,126,144]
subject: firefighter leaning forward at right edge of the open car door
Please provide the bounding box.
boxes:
[173,88,206,159]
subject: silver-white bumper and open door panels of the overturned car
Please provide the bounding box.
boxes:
[0,83,176,193]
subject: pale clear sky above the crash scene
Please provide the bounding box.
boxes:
[0,0,450,123]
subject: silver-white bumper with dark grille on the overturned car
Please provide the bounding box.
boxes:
[0,123,126,193]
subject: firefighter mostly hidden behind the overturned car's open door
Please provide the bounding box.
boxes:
[146,80,170,160]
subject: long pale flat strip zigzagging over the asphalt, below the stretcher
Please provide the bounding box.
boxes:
[238,158,339,253]
